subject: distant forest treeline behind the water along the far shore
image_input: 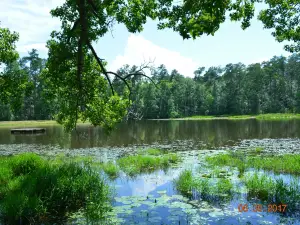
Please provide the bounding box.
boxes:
[0,49,300,120]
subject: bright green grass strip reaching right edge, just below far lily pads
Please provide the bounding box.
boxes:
[206,152,300,174]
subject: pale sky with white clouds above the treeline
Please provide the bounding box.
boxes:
[0,0,290,77]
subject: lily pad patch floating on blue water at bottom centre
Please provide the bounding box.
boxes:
[112,193,214,224]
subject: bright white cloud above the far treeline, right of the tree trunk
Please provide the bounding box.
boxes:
[109,34,199,77]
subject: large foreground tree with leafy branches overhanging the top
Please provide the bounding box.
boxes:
[1,0,300,129]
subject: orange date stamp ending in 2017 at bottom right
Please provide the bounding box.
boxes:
[238,204,288,213]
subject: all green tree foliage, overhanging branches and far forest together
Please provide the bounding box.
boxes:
[0,0,300,130]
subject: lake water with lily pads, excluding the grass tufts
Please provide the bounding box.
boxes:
[0,119,300,225]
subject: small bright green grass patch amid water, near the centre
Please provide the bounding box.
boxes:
[117,153,180,176]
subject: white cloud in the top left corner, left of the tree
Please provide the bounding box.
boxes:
[0,0,64,54]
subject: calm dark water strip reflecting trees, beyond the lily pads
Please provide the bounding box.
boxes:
[0,119,300,148]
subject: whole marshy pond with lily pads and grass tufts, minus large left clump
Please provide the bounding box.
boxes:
[0,119,300,224]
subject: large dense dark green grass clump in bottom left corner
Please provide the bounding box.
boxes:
[0,153,112,224]
